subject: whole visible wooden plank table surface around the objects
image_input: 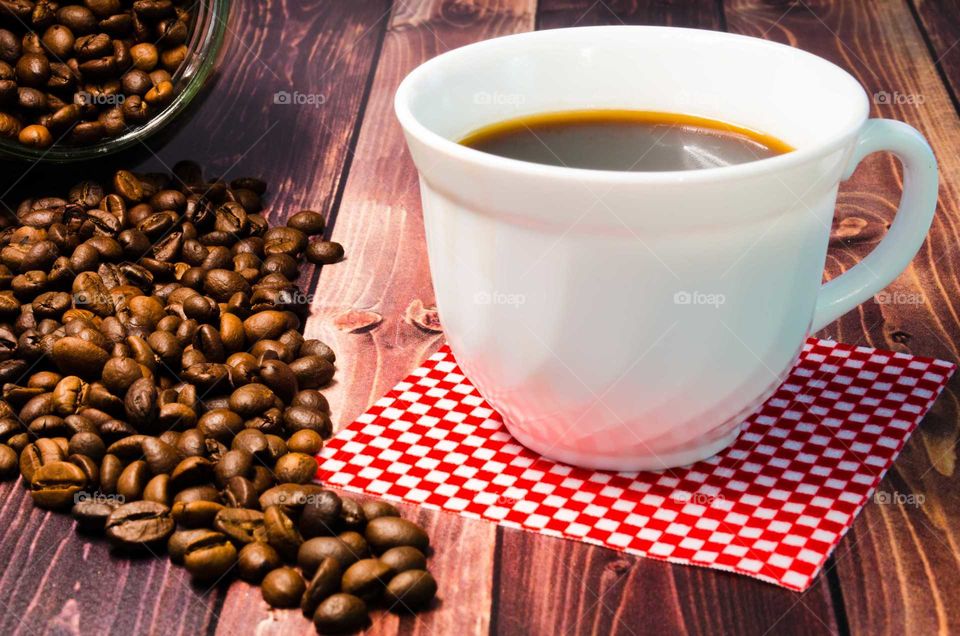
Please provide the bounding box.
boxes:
[0,0,960,636]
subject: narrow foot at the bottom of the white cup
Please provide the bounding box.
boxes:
[504,422,742,472]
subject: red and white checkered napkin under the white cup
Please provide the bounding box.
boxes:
[319,339,956,590]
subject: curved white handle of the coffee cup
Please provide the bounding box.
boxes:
[810,119,938,333]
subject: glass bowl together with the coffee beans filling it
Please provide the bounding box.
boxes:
[0,0,230,162]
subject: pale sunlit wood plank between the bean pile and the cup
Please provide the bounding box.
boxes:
[218,0,533,634]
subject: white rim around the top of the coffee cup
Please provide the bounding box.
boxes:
[394,25,870,185]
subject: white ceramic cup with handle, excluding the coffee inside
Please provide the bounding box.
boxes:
[395,26,937,470]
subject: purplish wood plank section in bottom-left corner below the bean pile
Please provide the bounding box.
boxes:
[0,481,224,636]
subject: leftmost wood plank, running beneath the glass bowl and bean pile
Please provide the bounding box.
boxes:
[0,0,389,634]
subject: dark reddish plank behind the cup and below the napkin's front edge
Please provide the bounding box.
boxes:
[494,0,837,634]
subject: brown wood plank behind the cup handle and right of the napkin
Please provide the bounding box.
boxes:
[725,0,960,634]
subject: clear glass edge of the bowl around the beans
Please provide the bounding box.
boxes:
[0,0,230,163]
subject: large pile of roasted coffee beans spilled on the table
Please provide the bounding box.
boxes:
[0,162,437,632]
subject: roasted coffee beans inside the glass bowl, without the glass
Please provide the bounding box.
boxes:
[0,0,193,148]
